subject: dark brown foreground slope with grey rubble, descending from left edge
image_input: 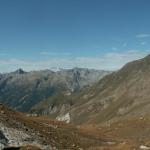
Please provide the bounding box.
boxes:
[0,104,122,150]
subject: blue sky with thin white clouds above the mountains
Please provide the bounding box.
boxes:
[0,0,150,72]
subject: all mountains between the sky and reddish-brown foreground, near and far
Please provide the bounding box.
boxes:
[0,55,150,124]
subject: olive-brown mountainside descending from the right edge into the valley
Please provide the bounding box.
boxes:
[60,55,150,124]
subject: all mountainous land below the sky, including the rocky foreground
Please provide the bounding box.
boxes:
[0,55,150,150]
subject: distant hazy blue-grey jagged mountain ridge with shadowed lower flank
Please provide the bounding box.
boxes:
[0,68,109,111]
